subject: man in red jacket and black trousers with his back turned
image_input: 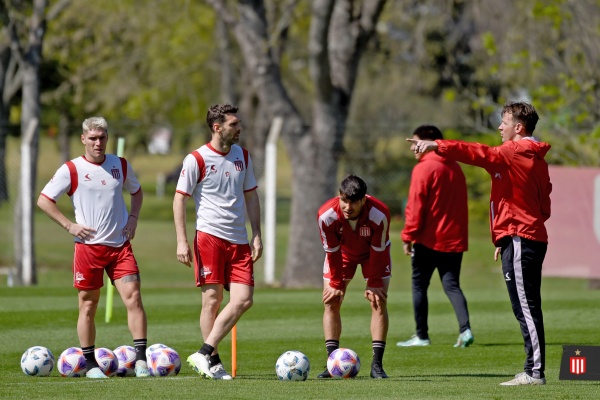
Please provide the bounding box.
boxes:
[397,125,473,347]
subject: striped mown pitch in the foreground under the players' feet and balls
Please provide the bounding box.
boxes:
[0,276,600,399]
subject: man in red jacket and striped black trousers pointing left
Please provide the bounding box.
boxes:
[407,102,552,386]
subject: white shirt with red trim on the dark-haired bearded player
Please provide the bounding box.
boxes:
[176,143,257,244]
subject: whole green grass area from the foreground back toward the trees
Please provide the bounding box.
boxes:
[0,137,600,399]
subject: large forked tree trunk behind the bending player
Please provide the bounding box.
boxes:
[207,0,385,287]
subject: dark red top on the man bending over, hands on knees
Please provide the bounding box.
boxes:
[317,195,390,289]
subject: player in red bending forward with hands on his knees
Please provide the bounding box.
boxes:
[318,175,392,379]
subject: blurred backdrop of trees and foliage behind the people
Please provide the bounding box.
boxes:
[0,0,600,284]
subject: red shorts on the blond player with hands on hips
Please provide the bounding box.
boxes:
[73,241,140,290]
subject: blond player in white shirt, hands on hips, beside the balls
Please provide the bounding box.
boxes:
[37,117,149,378]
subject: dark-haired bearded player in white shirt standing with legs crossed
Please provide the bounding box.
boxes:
[173,104,262,379]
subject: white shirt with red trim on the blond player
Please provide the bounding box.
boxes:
[42,154,140,247]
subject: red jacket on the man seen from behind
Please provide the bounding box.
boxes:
[402,153,469,253]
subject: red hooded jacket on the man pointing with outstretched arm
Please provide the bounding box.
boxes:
[436,137,552,245]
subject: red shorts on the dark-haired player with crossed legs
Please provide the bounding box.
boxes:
[194,231,254,289]
